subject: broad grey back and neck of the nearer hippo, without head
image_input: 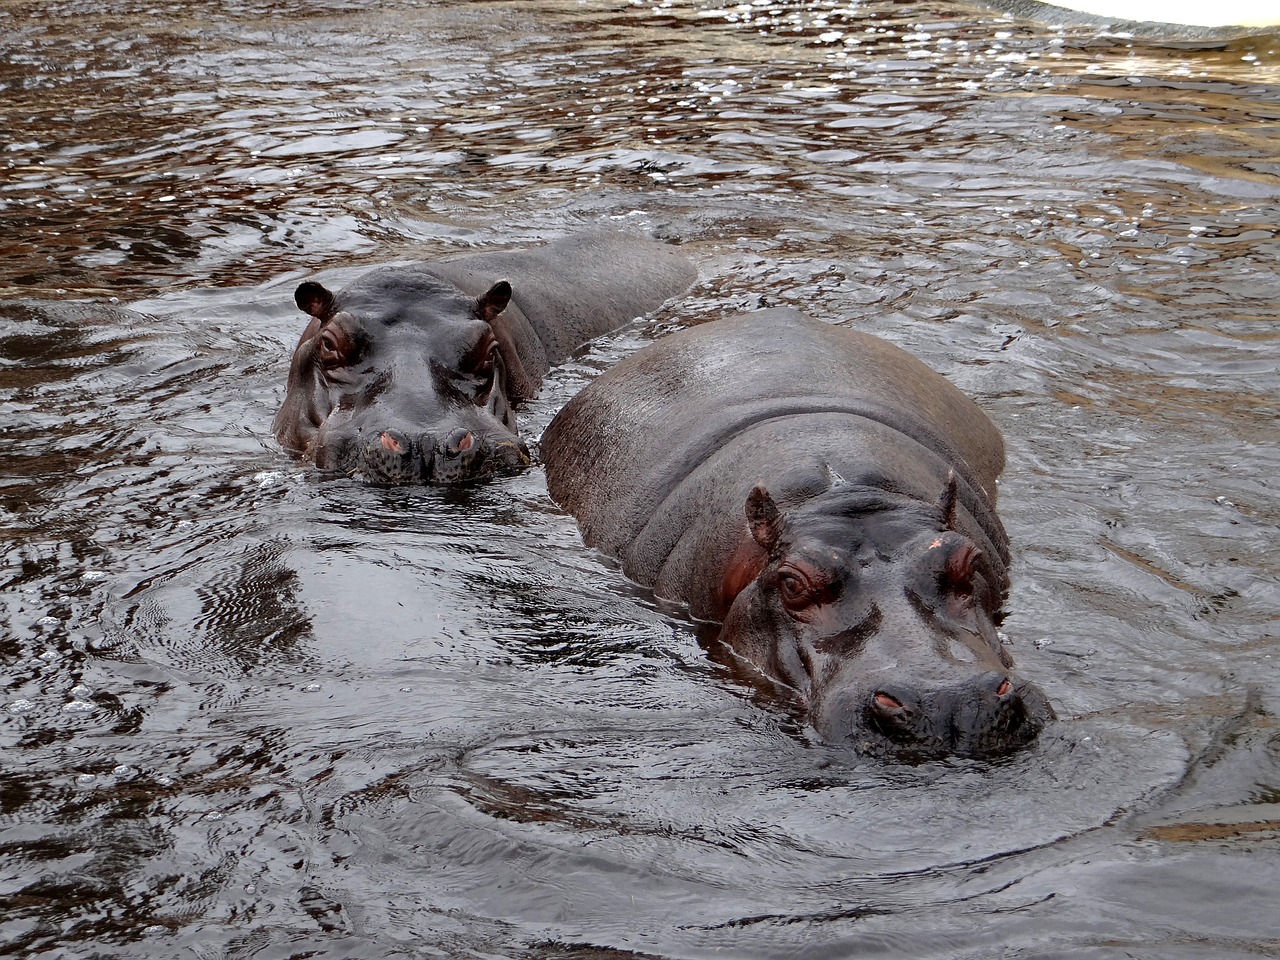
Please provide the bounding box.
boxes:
[541,310,1007,618]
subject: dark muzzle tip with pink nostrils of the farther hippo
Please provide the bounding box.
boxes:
[351,428,531,486]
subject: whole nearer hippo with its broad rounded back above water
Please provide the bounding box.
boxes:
[541,310,1053,758]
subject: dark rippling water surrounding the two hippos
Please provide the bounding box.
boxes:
[0,0,1280,960]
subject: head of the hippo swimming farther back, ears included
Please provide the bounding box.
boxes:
[275,268,532,484]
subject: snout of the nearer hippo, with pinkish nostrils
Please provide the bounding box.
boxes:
[824,672,1053,758]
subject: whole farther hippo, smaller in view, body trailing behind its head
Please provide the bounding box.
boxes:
[275,232,696,484]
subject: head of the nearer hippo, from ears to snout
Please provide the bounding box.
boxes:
[721,477,1053,759]
